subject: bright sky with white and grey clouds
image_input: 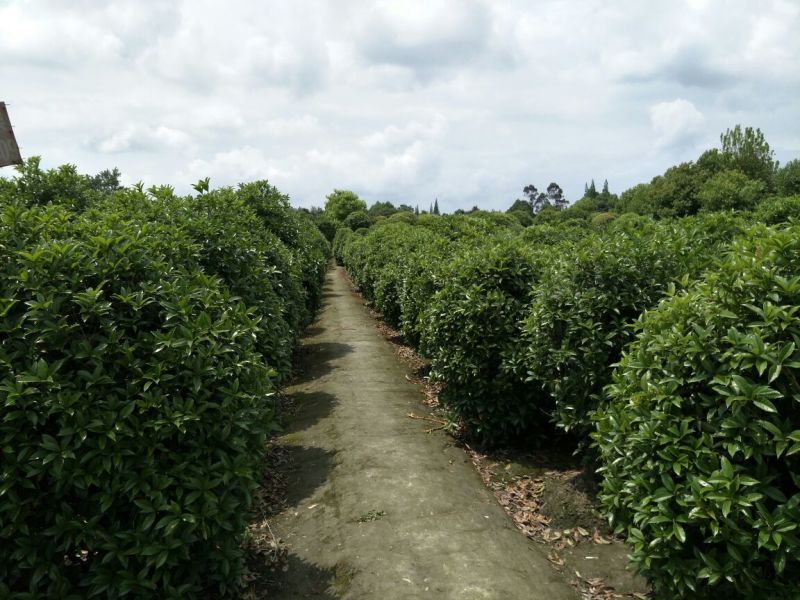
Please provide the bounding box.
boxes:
[0,0,800,211]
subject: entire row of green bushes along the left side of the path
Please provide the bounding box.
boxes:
[0,161,329,599]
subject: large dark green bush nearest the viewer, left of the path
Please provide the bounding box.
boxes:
[0,204,272,598]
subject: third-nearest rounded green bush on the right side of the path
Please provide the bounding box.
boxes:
[420,238,549,444]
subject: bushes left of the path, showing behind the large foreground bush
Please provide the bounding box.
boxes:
[96,184,329,381]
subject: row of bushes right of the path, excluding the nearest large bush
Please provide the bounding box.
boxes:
[335,215,744,444]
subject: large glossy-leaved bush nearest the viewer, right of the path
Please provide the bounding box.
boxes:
[594,225,800,599]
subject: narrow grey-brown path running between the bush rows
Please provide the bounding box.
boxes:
[270,267,577,600]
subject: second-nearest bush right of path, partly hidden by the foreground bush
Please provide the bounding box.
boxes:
[517,214,742,439]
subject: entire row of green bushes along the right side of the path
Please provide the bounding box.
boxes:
[336,209,800,597]
